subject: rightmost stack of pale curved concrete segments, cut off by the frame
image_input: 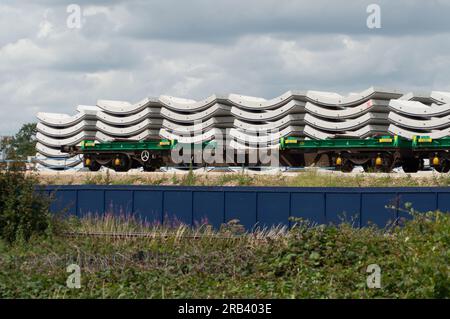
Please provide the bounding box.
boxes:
[389,91,450,139]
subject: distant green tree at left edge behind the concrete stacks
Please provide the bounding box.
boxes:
[2,123,37,160]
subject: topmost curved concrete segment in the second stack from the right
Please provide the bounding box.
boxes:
[306,87,403,106]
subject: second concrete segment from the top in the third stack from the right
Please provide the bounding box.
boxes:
[231,100,305,122]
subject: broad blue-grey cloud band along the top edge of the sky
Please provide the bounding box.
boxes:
[114,0,450,42]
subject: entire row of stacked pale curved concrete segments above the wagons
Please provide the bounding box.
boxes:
[40,87,450,168]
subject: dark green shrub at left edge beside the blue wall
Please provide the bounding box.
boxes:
[0,167,50,243]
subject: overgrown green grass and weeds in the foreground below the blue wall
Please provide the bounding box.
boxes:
[0,212,450,298]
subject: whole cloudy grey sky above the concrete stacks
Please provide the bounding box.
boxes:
[0,0,450,135]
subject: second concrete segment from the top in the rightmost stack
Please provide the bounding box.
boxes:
[389,100,450,117]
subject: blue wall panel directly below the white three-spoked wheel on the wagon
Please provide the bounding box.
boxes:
[133,190,163,224]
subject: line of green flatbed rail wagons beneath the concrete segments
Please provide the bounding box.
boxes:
[61,135,450,173]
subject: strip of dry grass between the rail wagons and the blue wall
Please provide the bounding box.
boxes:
[36,170,450,187]
